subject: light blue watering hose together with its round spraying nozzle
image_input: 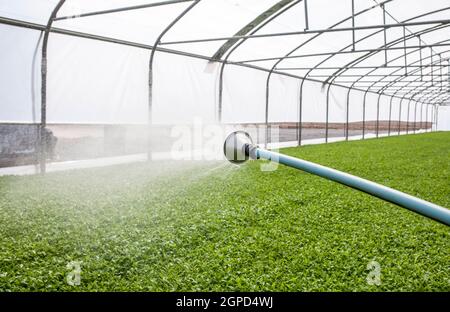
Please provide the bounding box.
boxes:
[223,131,450,226]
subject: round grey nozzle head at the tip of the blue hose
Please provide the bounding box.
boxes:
[223,131,257,164]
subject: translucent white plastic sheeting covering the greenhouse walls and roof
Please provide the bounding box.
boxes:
[0,0,450,130]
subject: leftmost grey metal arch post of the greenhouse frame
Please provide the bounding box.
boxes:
[39,0,66,174]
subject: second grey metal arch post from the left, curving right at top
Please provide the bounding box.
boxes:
[147,0,201,160]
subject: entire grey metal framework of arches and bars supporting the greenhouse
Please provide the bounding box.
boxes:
[1,0,450,172]
